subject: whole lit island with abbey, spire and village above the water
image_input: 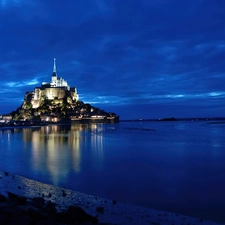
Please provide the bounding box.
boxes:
[0,59,119,124]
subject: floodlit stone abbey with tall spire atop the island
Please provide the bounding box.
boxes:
[24,58,79,108]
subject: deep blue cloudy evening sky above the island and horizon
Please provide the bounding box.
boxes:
[0,0,225,119]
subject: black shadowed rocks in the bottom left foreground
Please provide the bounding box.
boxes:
[0,192,100,225]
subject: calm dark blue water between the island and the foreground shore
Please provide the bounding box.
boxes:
[0,121,225,222]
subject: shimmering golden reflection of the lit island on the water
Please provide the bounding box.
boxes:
[0,123,105,185]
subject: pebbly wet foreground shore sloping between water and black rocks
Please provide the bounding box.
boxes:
[0,171,223,225]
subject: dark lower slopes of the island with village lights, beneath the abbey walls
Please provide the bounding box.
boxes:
[10,97,119,123]
